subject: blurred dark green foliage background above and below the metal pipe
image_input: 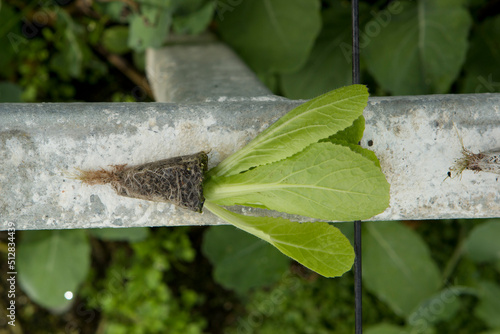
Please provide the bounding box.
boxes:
[0,0,500,334]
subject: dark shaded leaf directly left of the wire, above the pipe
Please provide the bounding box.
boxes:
[280,1,356,99]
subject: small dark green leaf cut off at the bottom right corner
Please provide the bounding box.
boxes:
[474,282,500,329]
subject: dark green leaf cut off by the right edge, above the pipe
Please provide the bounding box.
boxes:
[462,15,500,93]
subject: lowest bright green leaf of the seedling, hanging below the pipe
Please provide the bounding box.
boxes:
[205,201,354,277]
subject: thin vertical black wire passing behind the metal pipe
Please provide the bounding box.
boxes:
[351,0,363,334]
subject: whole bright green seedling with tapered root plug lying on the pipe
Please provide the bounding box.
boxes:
[78,85,389,277]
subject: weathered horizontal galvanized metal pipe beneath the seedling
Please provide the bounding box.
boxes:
[0,94,500,229]
